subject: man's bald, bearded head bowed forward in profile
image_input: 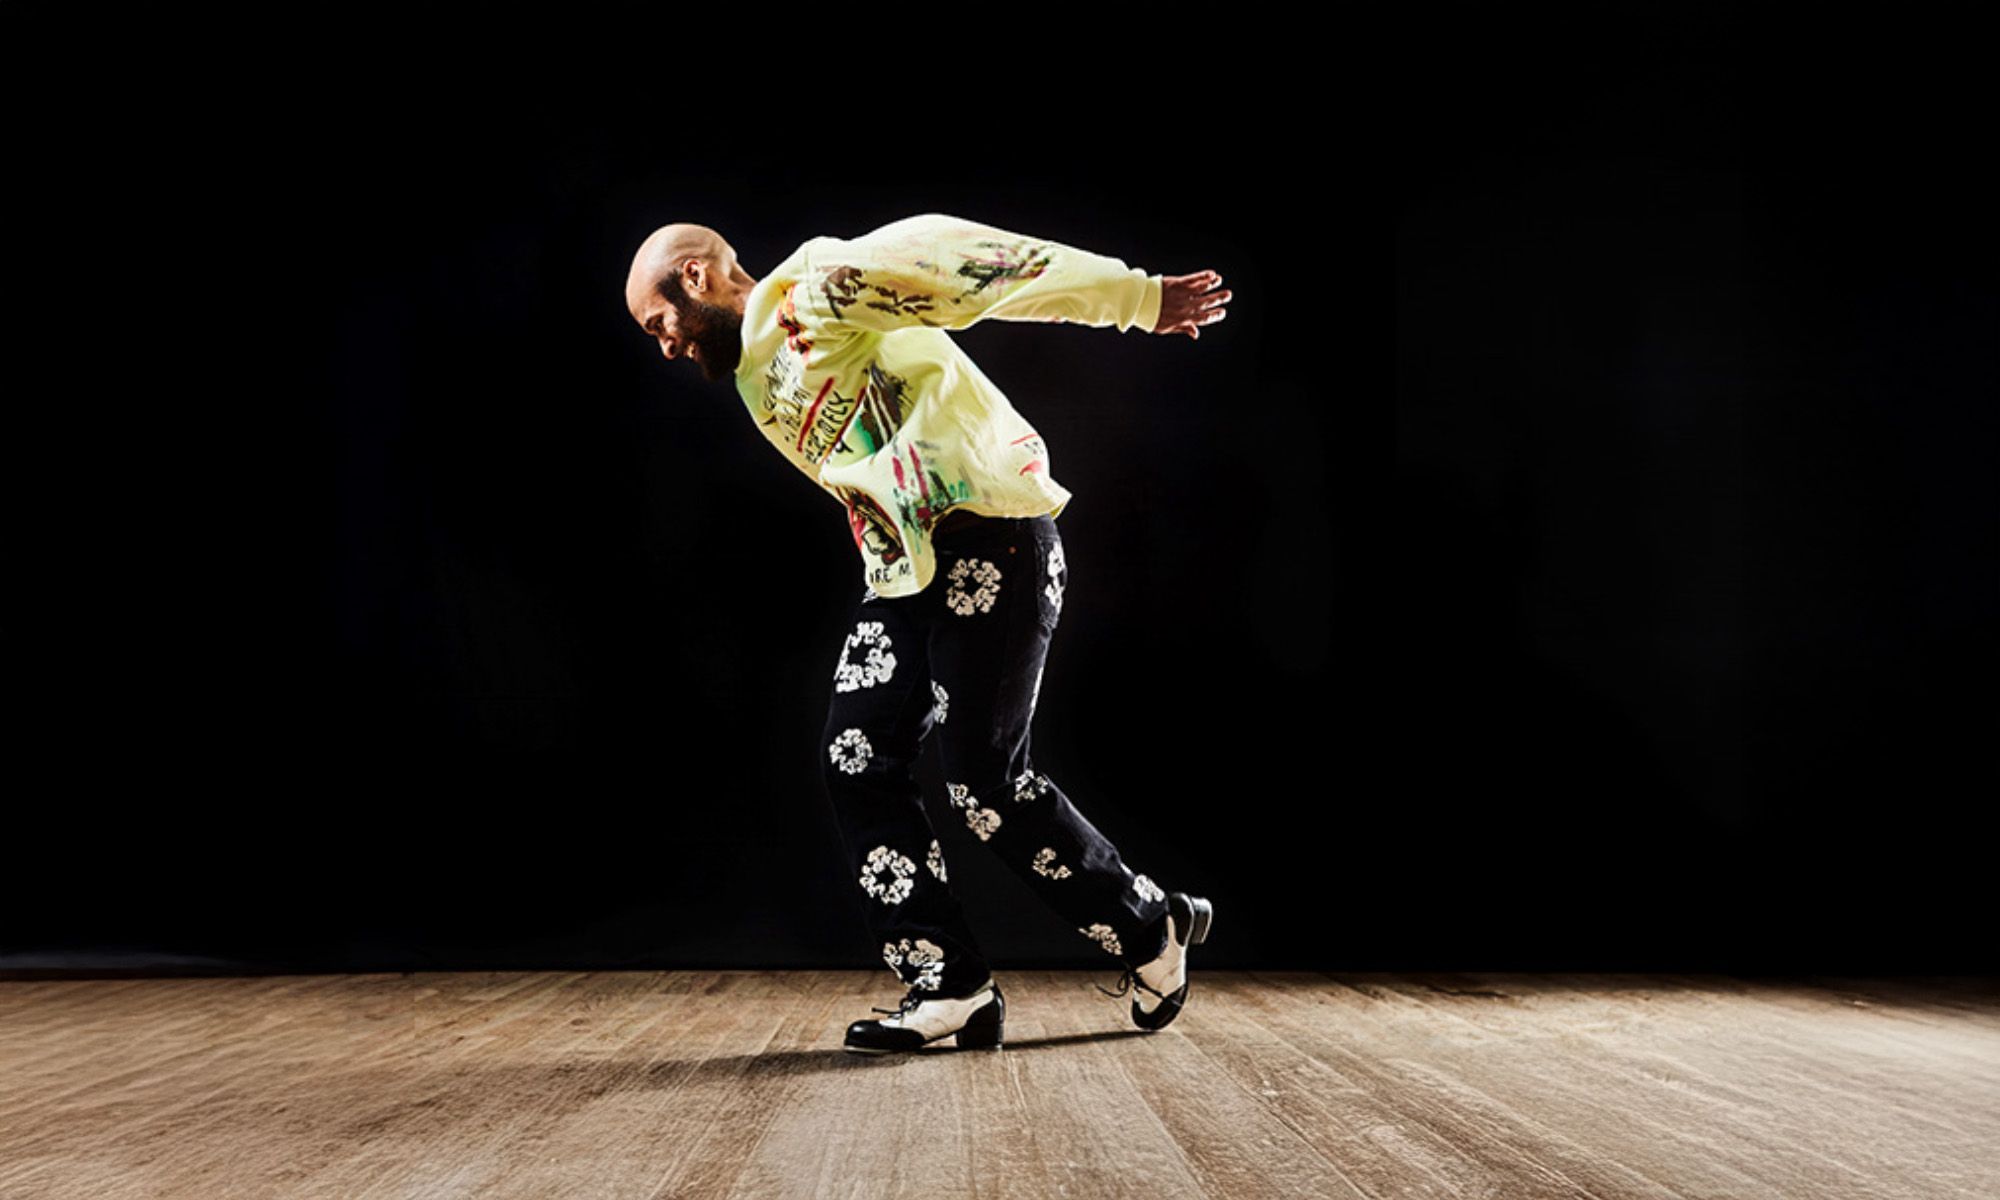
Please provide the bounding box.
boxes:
[626,222,756,380]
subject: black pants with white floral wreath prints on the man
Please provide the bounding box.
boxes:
[822,514,1166,996]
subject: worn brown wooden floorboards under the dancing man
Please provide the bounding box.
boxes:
[0,970,2000,1200]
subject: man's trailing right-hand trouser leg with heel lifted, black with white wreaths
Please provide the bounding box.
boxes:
[916,518,1166,964]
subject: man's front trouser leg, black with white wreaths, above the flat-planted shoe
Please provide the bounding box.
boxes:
[820,592,988,996]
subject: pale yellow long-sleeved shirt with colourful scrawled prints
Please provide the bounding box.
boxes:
[736,212,1162,596]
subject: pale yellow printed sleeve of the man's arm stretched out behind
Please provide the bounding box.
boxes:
[800,212,1186,332]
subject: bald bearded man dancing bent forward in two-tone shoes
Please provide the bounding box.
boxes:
[626,214,1230,1054]
